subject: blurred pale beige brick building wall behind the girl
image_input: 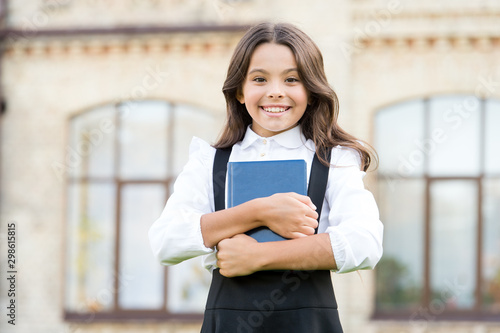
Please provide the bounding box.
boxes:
[0,0,500,333]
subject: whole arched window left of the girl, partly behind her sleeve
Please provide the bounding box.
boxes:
[65,101,218,321]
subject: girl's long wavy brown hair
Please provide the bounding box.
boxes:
[214,23,376,171]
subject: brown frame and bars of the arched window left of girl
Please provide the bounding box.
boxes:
[63,99,210,323]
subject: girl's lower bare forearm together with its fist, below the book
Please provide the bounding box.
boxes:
[217,234,337,277]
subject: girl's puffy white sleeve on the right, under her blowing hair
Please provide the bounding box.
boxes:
[325,147,383,273]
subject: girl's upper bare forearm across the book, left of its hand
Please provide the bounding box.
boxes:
[200,200,263,247]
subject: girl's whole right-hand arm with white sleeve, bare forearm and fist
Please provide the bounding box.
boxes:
[217,149,383,276]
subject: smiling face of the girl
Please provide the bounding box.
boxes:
[238,43,308,137]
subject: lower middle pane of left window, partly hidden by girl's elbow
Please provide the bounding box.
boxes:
[118,184,166,309]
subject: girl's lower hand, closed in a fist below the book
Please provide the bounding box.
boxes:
[216,234,259,277]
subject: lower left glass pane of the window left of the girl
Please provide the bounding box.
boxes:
[66,183,116,313]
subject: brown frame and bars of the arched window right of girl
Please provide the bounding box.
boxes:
[372,94,500,322]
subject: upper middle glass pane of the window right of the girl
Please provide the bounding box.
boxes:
[425,96,481,177]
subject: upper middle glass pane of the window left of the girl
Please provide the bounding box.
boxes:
[119,101,170,179]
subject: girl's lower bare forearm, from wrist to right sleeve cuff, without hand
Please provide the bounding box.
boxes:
[255,234,337,270]
